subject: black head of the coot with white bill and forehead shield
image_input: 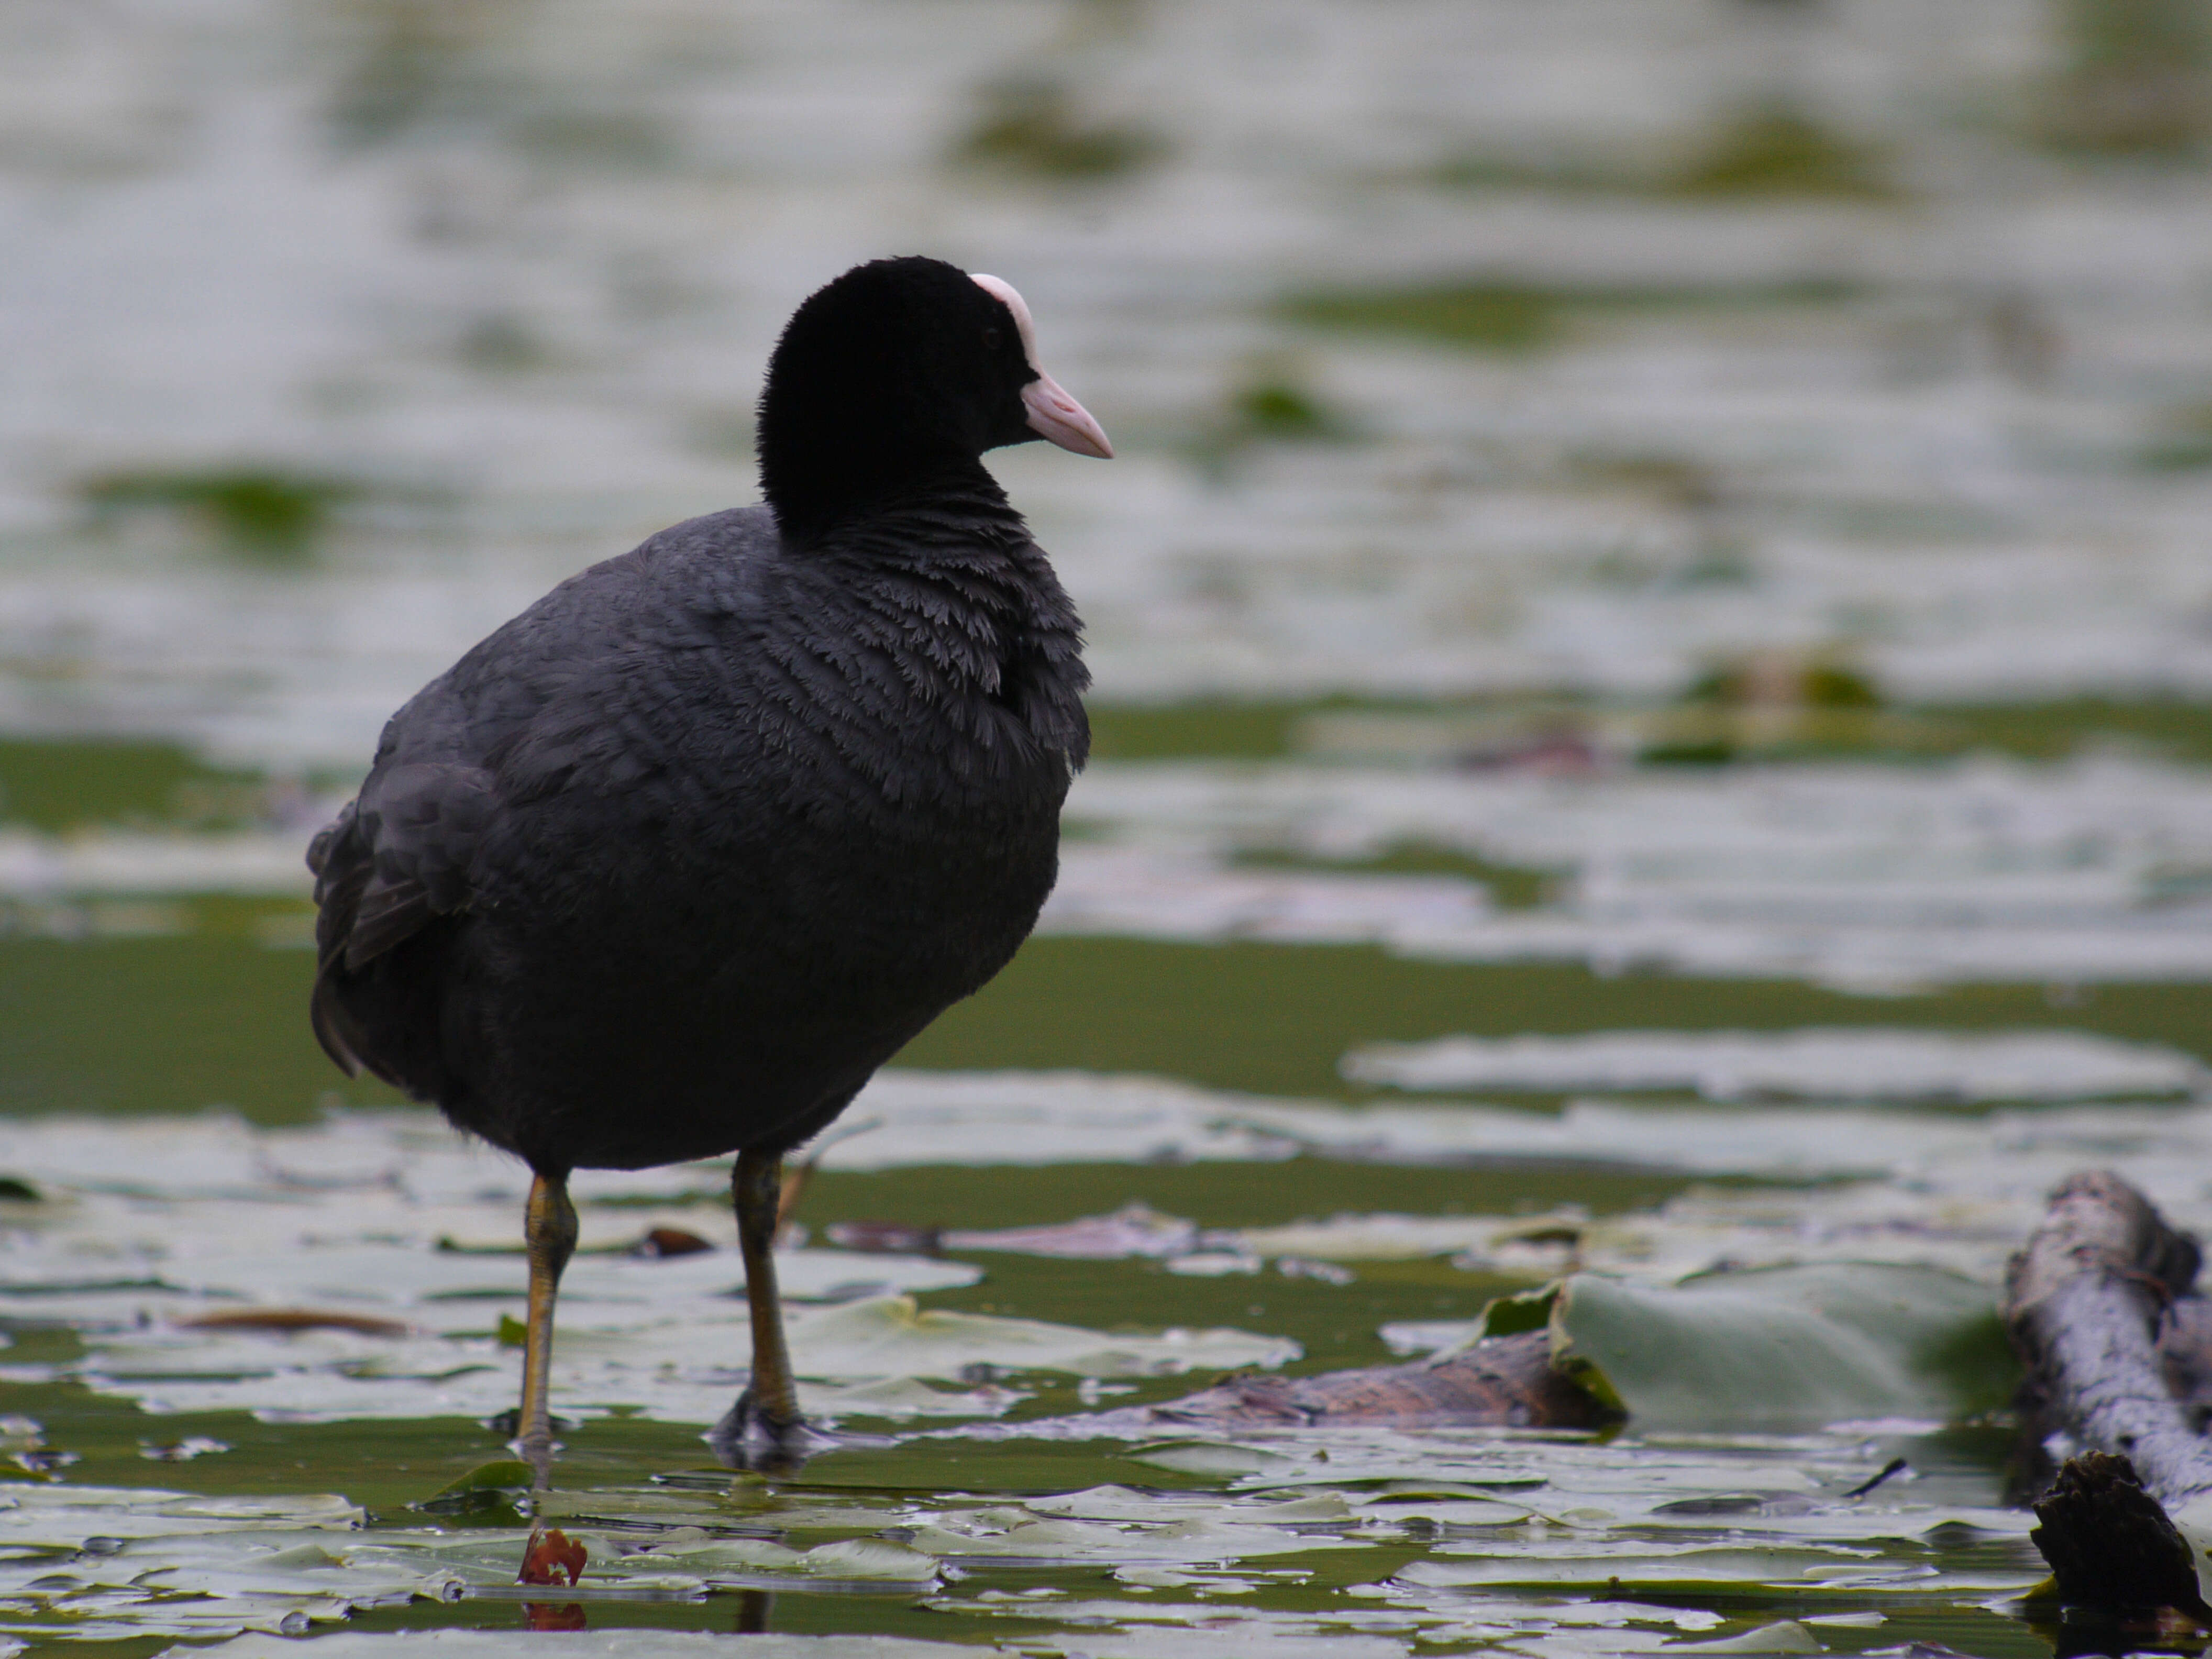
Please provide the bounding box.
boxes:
[759,257,1113,540]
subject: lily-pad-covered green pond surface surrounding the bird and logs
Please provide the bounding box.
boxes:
[13,0,2212,1659]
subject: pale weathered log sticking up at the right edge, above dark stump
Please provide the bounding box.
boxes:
[2004,1170,2212,1509]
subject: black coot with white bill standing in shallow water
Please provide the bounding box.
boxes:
[307,259,1113,1484]
